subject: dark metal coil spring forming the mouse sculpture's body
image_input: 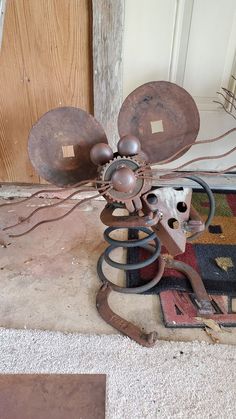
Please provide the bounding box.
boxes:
[97,227,164,294]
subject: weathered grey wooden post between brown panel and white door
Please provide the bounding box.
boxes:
[92,0,124,149]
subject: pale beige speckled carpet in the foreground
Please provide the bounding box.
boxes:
[0,329,236,419]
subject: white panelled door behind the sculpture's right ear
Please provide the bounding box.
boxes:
[123,0,236,170]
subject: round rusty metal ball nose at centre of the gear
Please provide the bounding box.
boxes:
[111,167,136,192]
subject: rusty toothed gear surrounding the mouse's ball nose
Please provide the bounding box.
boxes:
[99,156,151,212]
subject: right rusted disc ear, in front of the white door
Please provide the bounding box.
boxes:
[118,81,199,163]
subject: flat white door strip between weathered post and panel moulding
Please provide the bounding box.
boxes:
[123,0,175,97]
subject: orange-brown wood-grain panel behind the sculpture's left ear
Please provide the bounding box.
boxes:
[0,0,92,183]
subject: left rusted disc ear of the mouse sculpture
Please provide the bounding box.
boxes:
[28,107,107,186]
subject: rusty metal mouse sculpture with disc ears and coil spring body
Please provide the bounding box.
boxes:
[2,81,236,346]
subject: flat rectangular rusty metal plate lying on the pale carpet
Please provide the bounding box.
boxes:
[0,374,106,419]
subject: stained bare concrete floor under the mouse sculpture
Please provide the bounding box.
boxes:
[0,194,236,344]
